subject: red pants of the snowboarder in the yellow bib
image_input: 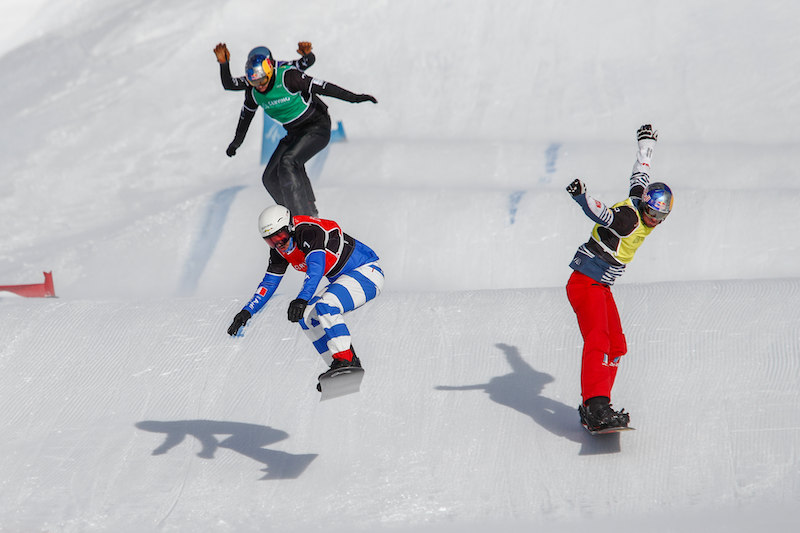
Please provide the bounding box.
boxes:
[567,271,628,402]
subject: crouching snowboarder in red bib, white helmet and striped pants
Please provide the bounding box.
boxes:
[228,205,384,390]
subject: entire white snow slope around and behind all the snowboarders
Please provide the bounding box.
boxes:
[0,0,800,532]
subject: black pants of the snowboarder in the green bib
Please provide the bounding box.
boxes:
[261,113,331,217]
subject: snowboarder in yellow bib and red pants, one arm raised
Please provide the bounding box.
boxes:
[567,124,672,433]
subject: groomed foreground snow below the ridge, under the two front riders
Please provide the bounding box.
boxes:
[0,279,800,531]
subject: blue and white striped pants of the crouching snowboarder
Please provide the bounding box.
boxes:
[300,261,383,365]
